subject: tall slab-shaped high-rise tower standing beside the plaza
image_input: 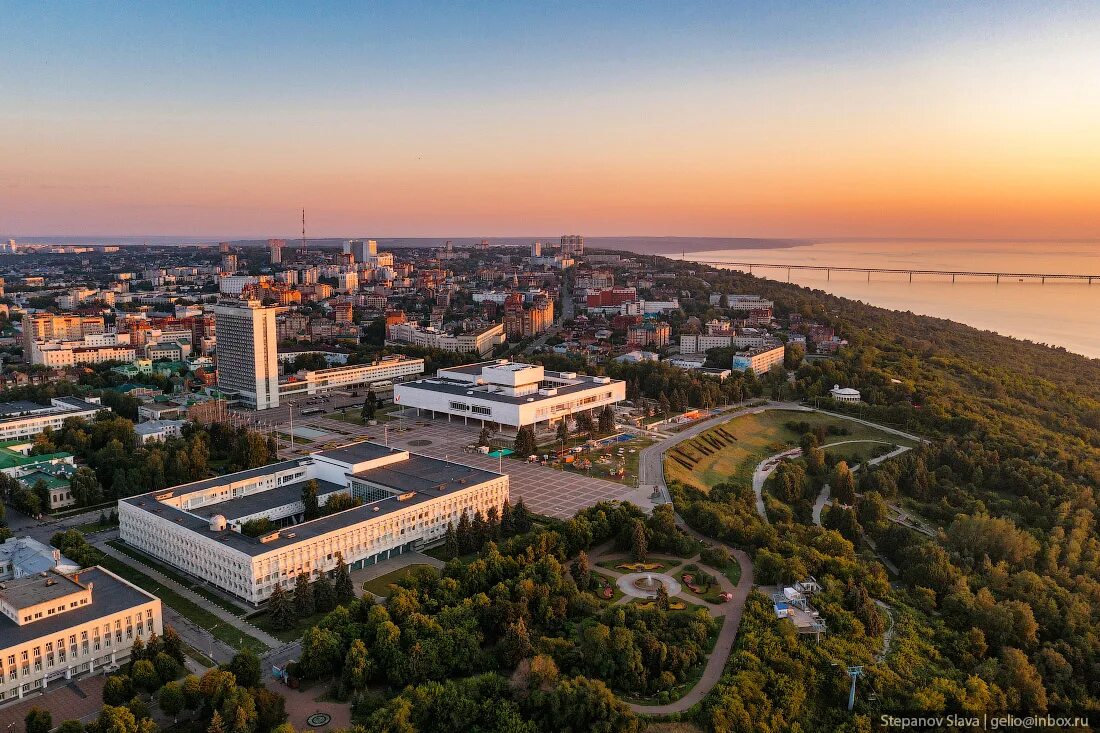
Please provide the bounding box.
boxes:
[213,300,279,409]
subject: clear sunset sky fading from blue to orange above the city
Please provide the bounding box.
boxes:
[0,0,1100,239]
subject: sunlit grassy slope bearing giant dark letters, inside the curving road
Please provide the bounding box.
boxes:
[664,409,912,491]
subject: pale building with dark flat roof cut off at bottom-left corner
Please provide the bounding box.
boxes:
[0,566,164,704]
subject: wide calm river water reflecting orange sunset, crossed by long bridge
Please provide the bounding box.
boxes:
[683,241,1100,359]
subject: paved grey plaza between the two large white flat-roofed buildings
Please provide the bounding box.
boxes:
[273,407,652,518]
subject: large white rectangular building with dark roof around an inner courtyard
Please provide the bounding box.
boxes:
[119,441,508,605]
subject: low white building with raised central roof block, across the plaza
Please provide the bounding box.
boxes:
[394,359,626,428]
